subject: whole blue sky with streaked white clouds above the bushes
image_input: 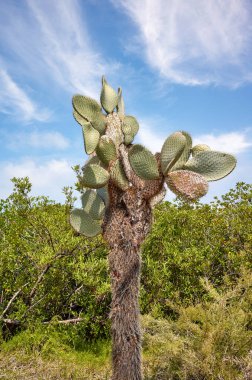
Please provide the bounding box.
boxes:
[0,0,252,202]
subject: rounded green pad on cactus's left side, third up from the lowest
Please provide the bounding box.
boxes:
[81,164,109,189]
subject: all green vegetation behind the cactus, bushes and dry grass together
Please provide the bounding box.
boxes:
[0,179,252,380]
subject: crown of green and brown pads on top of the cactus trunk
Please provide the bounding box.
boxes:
[70,77,236,237]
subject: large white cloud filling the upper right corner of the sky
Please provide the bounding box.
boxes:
[112,0,252,86]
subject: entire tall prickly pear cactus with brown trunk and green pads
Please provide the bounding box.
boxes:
[70,77,236,380]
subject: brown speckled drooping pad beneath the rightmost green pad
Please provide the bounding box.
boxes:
[166,170,208,201]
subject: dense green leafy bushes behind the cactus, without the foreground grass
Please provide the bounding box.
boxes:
[0,178,252,340]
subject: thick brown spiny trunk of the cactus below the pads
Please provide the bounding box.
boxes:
[103,184,151,380]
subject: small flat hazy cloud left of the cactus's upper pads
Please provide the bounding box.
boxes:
[5,131,69,150]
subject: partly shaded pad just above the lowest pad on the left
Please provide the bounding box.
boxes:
[81,190,105,219]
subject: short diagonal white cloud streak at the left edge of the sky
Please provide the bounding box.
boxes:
[0,68,50,122]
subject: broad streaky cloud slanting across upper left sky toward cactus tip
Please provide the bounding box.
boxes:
[0,0,117,96]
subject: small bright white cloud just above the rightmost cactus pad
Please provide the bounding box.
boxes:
[193,132,252,154]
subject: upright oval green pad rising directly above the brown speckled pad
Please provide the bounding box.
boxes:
[160,132,187,175]
